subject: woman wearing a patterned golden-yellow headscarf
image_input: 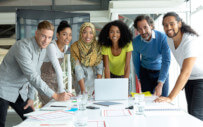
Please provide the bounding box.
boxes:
[71,22,103,95]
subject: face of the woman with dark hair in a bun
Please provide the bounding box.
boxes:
[57,27,72,45]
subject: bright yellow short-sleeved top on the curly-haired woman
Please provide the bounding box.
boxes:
[102,42,133,76]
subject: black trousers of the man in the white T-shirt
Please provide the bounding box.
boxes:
[185,79,203,121]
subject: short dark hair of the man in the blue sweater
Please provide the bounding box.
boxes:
[133,15,155,29]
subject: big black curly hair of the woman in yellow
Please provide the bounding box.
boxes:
[98,20,132,48]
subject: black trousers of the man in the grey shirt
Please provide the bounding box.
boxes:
[0,95,33,127]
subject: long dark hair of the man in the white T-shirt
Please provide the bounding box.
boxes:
[162,12,199,36]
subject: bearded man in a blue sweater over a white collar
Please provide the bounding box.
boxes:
[132,15,171,96]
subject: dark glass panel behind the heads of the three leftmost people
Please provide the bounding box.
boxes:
[16,9,90,44]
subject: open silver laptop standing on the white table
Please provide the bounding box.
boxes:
[94,78,128,101]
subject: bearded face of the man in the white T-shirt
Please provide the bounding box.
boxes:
[163,16,181,38]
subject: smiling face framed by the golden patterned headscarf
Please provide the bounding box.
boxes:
[82,26,94,43]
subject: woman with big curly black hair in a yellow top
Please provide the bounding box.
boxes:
[99,20,133,78]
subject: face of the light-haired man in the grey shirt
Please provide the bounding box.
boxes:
[35,29,54,48]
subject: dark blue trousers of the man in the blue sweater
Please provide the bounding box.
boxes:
[140,67,169,97]
